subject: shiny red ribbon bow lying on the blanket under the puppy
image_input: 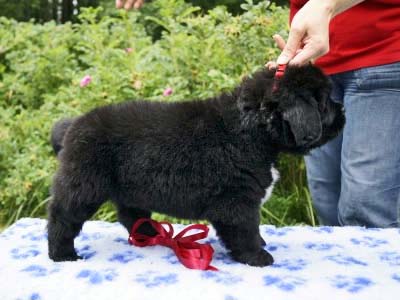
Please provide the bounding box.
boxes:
[128,218,218,271]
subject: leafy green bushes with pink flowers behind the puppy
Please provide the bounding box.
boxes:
[0,0,314,225]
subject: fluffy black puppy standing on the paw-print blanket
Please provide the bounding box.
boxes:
[48,66,345,266]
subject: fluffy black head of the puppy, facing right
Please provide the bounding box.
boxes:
[238,65,345,154]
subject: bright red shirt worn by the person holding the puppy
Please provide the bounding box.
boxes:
[290,0,400,74]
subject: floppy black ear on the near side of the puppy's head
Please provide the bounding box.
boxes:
[282,95,322,146]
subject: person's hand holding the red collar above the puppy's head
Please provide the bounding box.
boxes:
[274,0,334,65]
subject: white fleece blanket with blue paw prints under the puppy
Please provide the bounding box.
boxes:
[0,219,400,300]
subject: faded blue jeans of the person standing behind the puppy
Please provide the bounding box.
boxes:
[305,62,400,227]
